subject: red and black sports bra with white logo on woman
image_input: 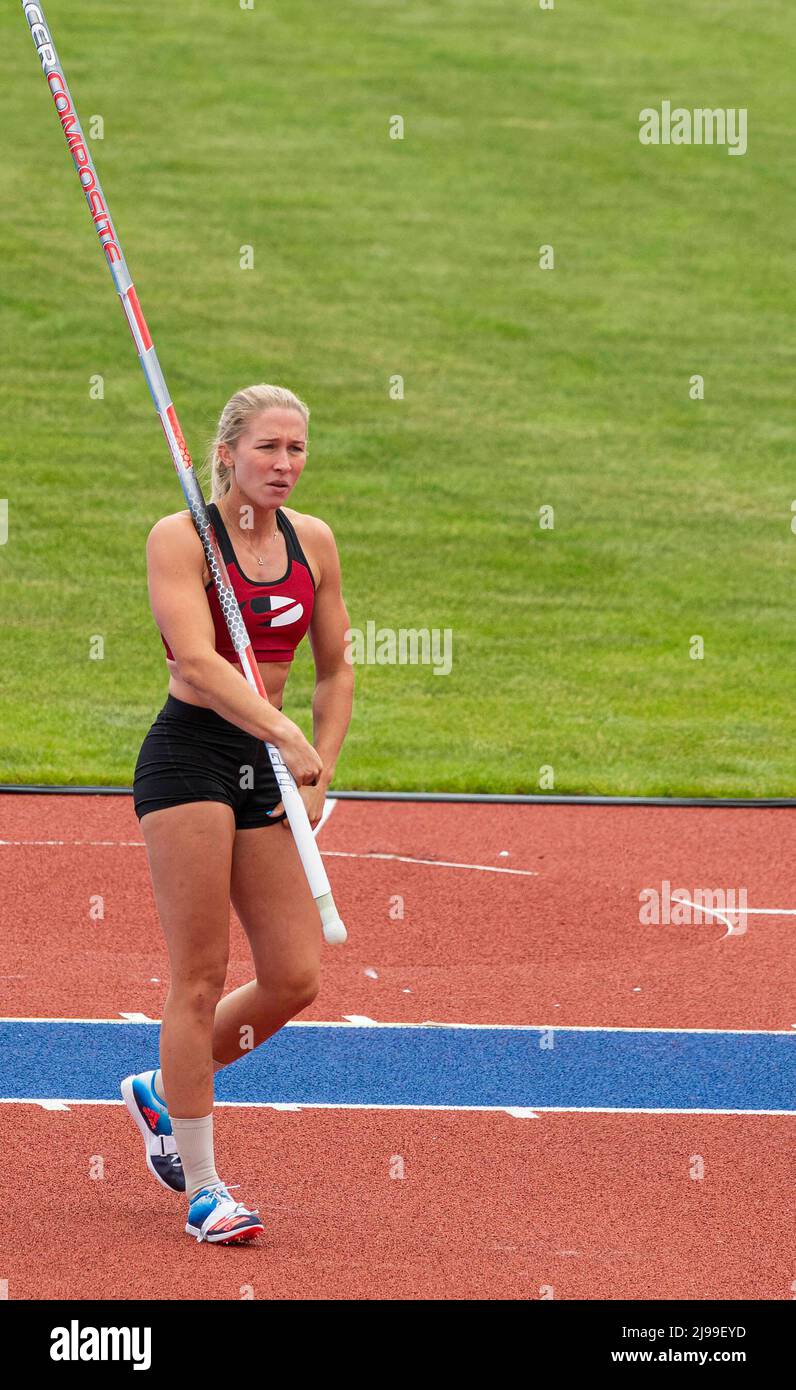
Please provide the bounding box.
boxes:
[160,502,315,662]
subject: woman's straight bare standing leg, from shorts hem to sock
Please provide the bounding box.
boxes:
[140,801,235,1120]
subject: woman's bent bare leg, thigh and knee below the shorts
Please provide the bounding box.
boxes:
[213,821,322,1065]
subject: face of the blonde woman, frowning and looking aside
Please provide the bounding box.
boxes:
[226,406,307,507]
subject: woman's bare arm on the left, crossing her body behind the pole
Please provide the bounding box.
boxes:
[146,513,322,785]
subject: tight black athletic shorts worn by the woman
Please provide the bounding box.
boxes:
[133,695,285,830]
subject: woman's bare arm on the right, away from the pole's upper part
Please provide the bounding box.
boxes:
[300,517,354,824]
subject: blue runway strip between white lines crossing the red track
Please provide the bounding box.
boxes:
[0,1020,796,1112]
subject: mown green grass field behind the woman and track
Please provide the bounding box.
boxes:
[0,0,796,796]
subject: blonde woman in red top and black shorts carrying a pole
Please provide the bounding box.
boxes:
[121,385,353,1244]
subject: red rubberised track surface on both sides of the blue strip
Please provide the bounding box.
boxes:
[0,795,796,1300]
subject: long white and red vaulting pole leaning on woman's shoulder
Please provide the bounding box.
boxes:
[22,0,346,942]
